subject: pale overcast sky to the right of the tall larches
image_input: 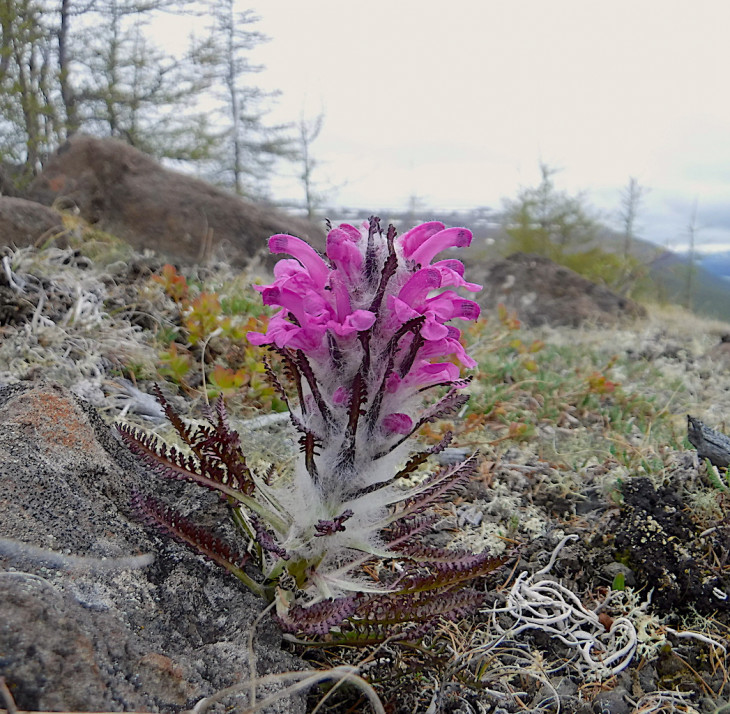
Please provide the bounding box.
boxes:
[226,0,730,248]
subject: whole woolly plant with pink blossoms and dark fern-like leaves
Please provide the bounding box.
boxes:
[120,218,500,634]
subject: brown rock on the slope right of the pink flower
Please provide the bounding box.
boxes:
[470,253,646,327]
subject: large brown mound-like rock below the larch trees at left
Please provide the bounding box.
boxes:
[28,135,324,267]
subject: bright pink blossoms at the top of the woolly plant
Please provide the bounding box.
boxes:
[248,219,481,433]
